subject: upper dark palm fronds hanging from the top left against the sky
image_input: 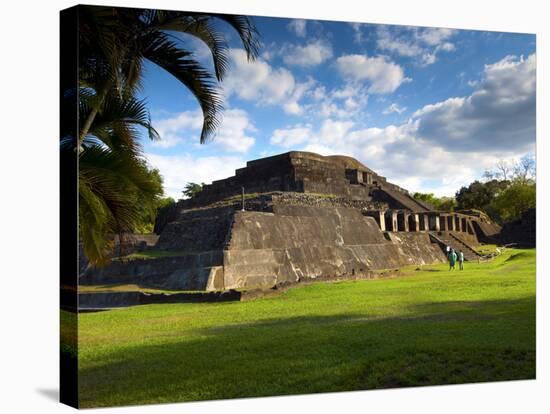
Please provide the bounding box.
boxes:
[79,6,259,143]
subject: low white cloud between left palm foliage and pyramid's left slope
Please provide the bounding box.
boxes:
[145,153,246,200]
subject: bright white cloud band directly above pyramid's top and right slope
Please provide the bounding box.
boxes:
[272,120,508,196]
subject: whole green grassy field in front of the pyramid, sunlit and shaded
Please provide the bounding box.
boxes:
[71,249,535,407]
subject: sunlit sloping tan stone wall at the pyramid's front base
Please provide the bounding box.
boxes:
[224,205,445,289]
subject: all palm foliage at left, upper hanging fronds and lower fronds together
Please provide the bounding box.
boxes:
[70,6,259,265]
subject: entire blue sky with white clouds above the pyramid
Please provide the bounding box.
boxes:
[136,17,536,198]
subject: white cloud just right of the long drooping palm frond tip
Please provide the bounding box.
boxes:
[222,49,312,114]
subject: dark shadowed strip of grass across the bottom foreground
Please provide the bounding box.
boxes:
[79,297,535,407]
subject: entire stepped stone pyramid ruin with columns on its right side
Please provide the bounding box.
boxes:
[81,151,500,291]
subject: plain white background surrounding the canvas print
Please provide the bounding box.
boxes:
[0,0,550,414]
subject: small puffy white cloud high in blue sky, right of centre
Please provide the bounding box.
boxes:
[336,55,410,94]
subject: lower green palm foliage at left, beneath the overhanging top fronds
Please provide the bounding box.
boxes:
[61,90,163,265]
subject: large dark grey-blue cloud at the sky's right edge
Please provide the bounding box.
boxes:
[413,54,536,152]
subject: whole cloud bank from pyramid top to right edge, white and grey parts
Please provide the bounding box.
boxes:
[271,55,536,196]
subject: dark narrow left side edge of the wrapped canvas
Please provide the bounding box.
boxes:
[59,7,78,408]
